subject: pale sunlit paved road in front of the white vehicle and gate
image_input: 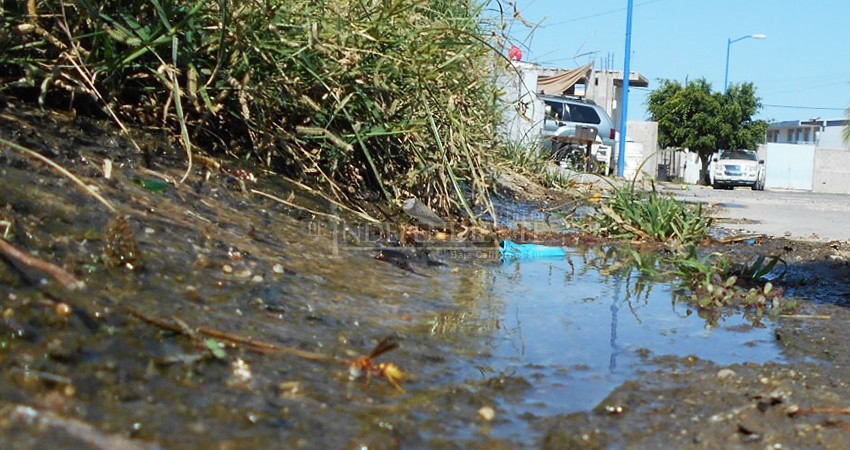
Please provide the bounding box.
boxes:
[664,184,850,242]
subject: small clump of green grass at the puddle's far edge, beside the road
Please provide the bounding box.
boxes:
[590,182,711,247]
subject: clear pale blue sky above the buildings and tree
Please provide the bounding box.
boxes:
[504,0,850,121]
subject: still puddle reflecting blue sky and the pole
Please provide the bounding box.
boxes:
[428,246,782,440]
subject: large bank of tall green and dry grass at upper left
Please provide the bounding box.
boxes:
[0,0,524,221]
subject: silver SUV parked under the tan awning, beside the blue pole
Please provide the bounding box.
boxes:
[539,95,617,173]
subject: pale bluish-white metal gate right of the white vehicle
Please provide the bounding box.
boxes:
[764,142,815,191]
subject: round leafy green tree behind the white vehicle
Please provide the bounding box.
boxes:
[647,78,768,169]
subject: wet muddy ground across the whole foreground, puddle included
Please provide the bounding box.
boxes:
[0,105,850,449]
